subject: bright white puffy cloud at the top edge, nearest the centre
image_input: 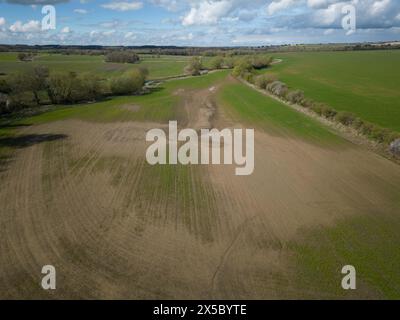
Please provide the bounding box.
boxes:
[182,0,233,26]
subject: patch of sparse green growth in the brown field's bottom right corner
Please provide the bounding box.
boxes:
[288,211,400,299]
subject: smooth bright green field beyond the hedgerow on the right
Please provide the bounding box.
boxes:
[268,51,400,132]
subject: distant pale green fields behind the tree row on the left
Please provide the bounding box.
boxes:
[0,52,190,79]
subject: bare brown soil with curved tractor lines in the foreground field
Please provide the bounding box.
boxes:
[0,81,400,299]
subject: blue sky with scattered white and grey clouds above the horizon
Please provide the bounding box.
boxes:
[0,0,400,46]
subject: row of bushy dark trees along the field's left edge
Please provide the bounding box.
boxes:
[0,66,148,114]
